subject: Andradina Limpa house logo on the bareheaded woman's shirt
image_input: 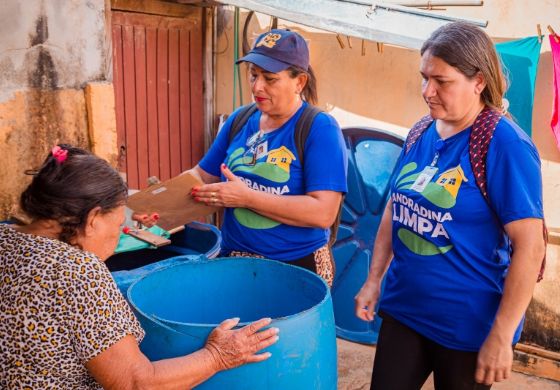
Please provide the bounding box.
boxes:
[391,162,468,256]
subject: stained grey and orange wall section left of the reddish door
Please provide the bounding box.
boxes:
[0,0,110,219]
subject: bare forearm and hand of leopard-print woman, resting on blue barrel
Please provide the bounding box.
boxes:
[86,318,278,390]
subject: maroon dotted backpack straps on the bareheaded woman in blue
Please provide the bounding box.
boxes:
[404,107,548,282]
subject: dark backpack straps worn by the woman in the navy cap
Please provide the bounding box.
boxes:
[229,103,344,247]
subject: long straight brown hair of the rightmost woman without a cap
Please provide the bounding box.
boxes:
[420,22,507,111]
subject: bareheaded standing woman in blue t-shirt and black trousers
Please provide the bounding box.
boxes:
[356,22,545,390]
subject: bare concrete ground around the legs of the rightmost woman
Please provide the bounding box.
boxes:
[337,339,560,390]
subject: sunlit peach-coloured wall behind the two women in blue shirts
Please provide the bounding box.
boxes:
[215,0,560,351]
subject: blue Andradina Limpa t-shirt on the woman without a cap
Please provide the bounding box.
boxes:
[380,118,543,351]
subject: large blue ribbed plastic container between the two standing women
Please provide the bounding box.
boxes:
[331,128,404,344]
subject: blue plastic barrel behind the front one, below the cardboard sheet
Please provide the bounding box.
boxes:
[105,222,222,297]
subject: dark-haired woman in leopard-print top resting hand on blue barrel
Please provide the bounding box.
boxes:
[0,145,278,389]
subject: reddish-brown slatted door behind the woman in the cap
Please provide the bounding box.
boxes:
[112,11,204,189]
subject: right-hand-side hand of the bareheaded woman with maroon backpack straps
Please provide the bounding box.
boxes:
[475,332,513,385]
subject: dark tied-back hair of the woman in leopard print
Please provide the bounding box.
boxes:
[20,144,127,243]
